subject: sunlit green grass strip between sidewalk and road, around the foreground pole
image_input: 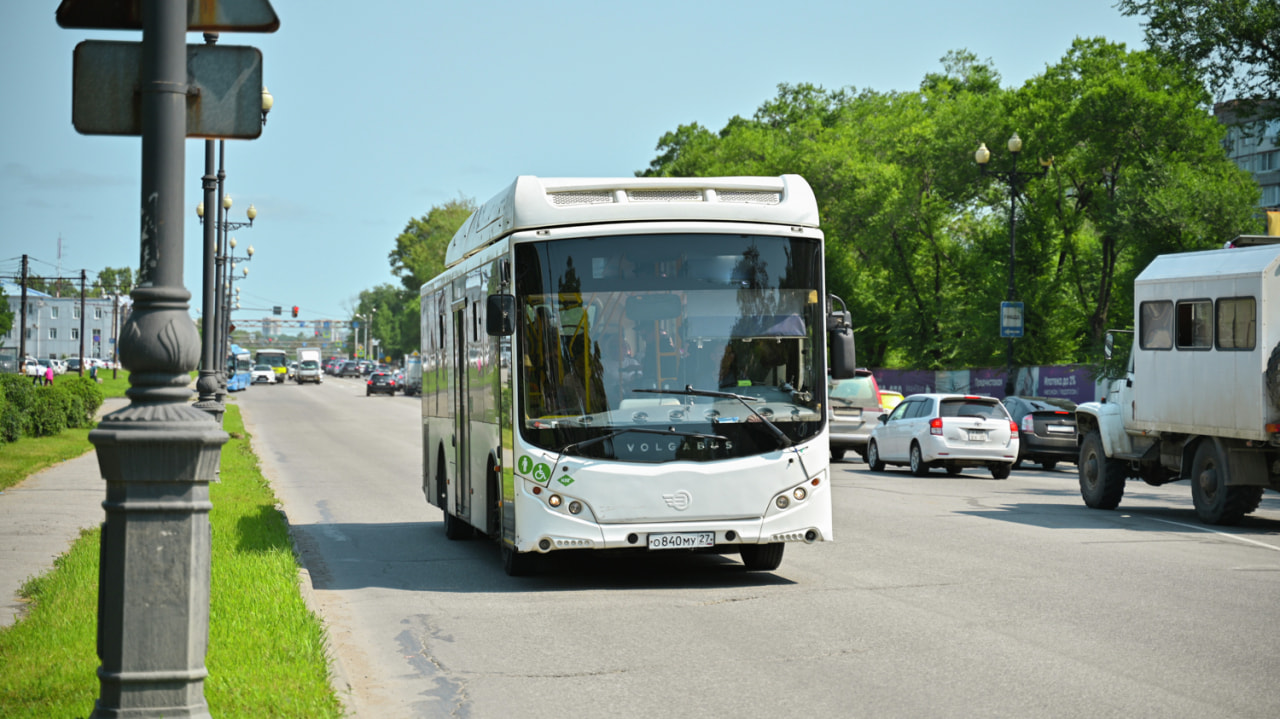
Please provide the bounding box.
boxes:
[0,404,343,719]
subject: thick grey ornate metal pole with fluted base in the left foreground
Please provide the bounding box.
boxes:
[88,0,228,718]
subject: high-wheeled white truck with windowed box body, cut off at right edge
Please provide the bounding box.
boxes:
[1076,238,1280,525]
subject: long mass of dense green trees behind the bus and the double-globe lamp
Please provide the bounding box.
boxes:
[644,40,1260,368]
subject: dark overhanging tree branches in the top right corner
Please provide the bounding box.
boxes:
[1116,0,1280,119]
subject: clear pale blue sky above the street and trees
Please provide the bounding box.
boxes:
[0,0,1143,330]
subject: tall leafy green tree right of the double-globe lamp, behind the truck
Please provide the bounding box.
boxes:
[1012,38,1258,348]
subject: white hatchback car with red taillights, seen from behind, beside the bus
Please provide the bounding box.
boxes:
[867,394,1018,480]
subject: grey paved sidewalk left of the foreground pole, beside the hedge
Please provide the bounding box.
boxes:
[0,397,129,627]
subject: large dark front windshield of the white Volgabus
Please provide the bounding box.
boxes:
[515,233,826,462]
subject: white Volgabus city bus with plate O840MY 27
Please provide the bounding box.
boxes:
[421,175,854,574]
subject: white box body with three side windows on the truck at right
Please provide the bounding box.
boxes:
[1121,244,1280,440]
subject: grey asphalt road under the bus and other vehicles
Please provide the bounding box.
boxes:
[234,377,1280,719]
